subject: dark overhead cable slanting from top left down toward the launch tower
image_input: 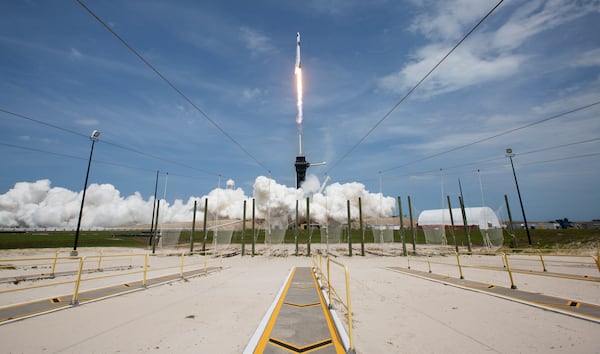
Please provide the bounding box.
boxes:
[75,0,270,172]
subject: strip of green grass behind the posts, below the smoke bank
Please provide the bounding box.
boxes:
[0,229,600,249]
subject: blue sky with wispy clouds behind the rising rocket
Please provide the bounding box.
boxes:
[0,0,600,220]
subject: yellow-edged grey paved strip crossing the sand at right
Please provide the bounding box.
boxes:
[384,267,600,323]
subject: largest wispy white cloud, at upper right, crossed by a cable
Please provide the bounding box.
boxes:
[379,0,598,97]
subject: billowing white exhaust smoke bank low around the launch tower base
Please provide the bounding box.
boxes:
[0,176,395,228]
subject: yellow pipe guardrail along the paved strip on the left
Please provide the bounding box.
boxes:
[0,251,223,305]
